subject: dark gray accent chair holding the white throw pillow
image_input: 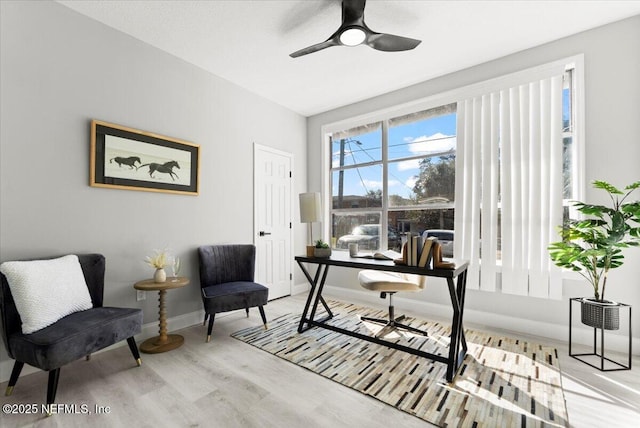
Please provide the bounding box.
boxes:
[0,254,142,404]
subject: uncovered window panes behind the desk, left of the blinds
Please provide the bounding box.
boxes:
[330,104,456,251]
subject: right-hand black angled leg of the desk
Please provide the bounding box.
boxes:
[446,271,467,382]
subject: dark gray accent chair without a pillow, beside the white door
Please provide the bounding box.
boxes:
[198,244,269,342]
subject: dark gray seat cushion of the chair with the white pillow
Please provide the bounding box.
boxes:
[8,307,142,370]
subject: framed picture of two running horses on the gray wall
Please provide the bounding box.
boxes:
[89,120,200,195]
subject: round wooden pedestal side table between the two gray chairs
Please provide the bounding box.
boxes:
[133,276,189,354]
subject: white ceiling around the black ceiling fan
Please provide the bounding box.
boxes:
[59,0,640,116]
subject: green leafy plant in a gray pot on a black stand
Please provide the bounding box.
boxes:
[548,181,640,330]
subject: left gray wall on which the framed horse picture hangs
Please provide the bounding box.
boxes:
[0,1,306,368]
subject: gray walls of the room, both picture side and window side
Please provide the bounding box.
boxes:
[0,1,640,377]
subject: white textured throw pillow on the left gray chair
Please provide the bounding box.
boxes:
[0,255,93,334]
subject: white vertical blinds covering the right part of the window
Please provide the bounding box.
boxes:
[454,72,563,299]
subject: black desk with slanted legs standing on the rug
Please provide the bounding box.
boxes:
[295,251,468,382]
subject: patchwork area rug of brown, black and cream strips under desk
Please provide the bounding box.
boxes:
[232,301,569,427]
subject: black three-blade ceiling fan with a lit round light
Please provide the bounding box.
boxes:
[289,0,421,58]
